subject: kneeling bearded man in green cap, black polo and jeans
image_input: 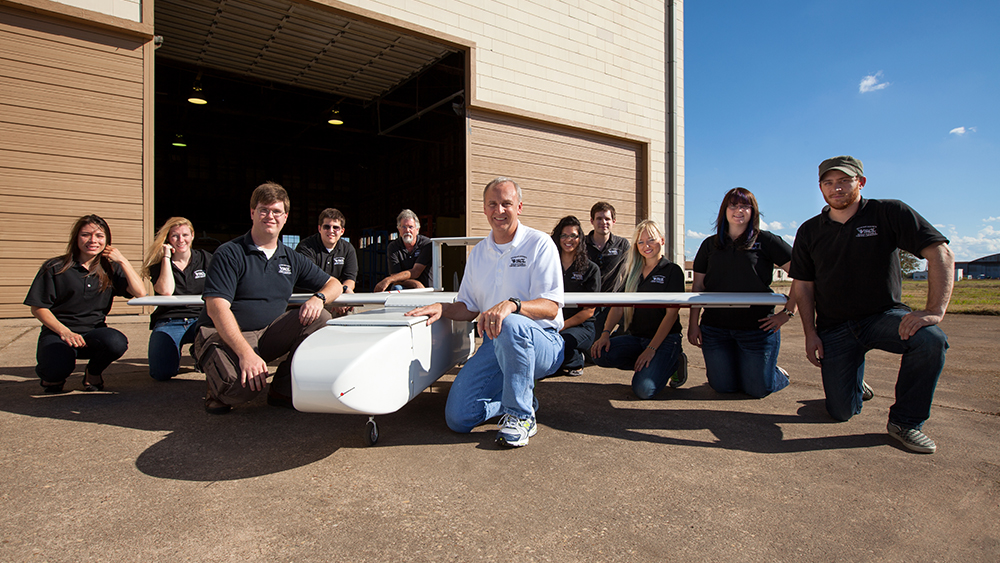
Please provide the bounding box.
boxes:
[789,156,955,453]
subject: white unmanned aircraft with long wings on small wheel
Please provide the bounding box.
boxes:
[128,237,786,445]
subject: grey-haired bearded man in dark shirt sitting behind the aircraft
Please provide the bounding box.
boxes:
[375,209,432,292]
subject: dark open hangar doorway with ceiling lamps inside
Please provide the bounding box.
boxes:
[154,0,467,290]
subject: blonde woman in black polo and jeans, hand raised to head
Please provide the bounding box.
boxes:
[142,217,212,381]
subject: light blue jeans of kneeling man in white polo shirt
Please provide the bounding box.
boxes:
[444,315,563,432]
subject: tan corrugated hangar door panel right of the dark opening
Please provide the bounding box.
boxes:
[468,110,648,238]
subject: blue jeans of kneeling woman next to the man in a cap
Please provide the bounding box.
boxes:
[701,325,788,399]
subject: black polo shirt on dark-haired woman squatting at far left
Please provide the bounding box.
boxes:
[24,257,132,334]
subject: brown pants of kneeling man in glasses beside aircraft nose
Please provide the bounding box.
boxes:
[193,309,331,406]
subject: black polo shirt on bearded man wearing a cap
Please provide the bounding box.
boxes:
[791,198,948,329]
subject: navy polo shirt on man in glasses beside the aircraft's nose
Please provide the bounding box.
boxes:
[199,232,330,331]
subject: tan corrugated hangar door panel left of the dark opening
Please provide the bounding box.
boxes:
[0,7,143,317]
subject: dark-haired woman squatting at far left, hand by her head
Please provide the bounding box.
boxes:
[24,215,146,393]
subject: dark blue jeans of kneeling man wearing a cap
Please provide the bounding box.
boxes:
[819,309,948,428]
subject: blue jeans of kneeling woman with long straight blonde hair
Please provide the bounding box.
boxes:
[594,334,681,399]
